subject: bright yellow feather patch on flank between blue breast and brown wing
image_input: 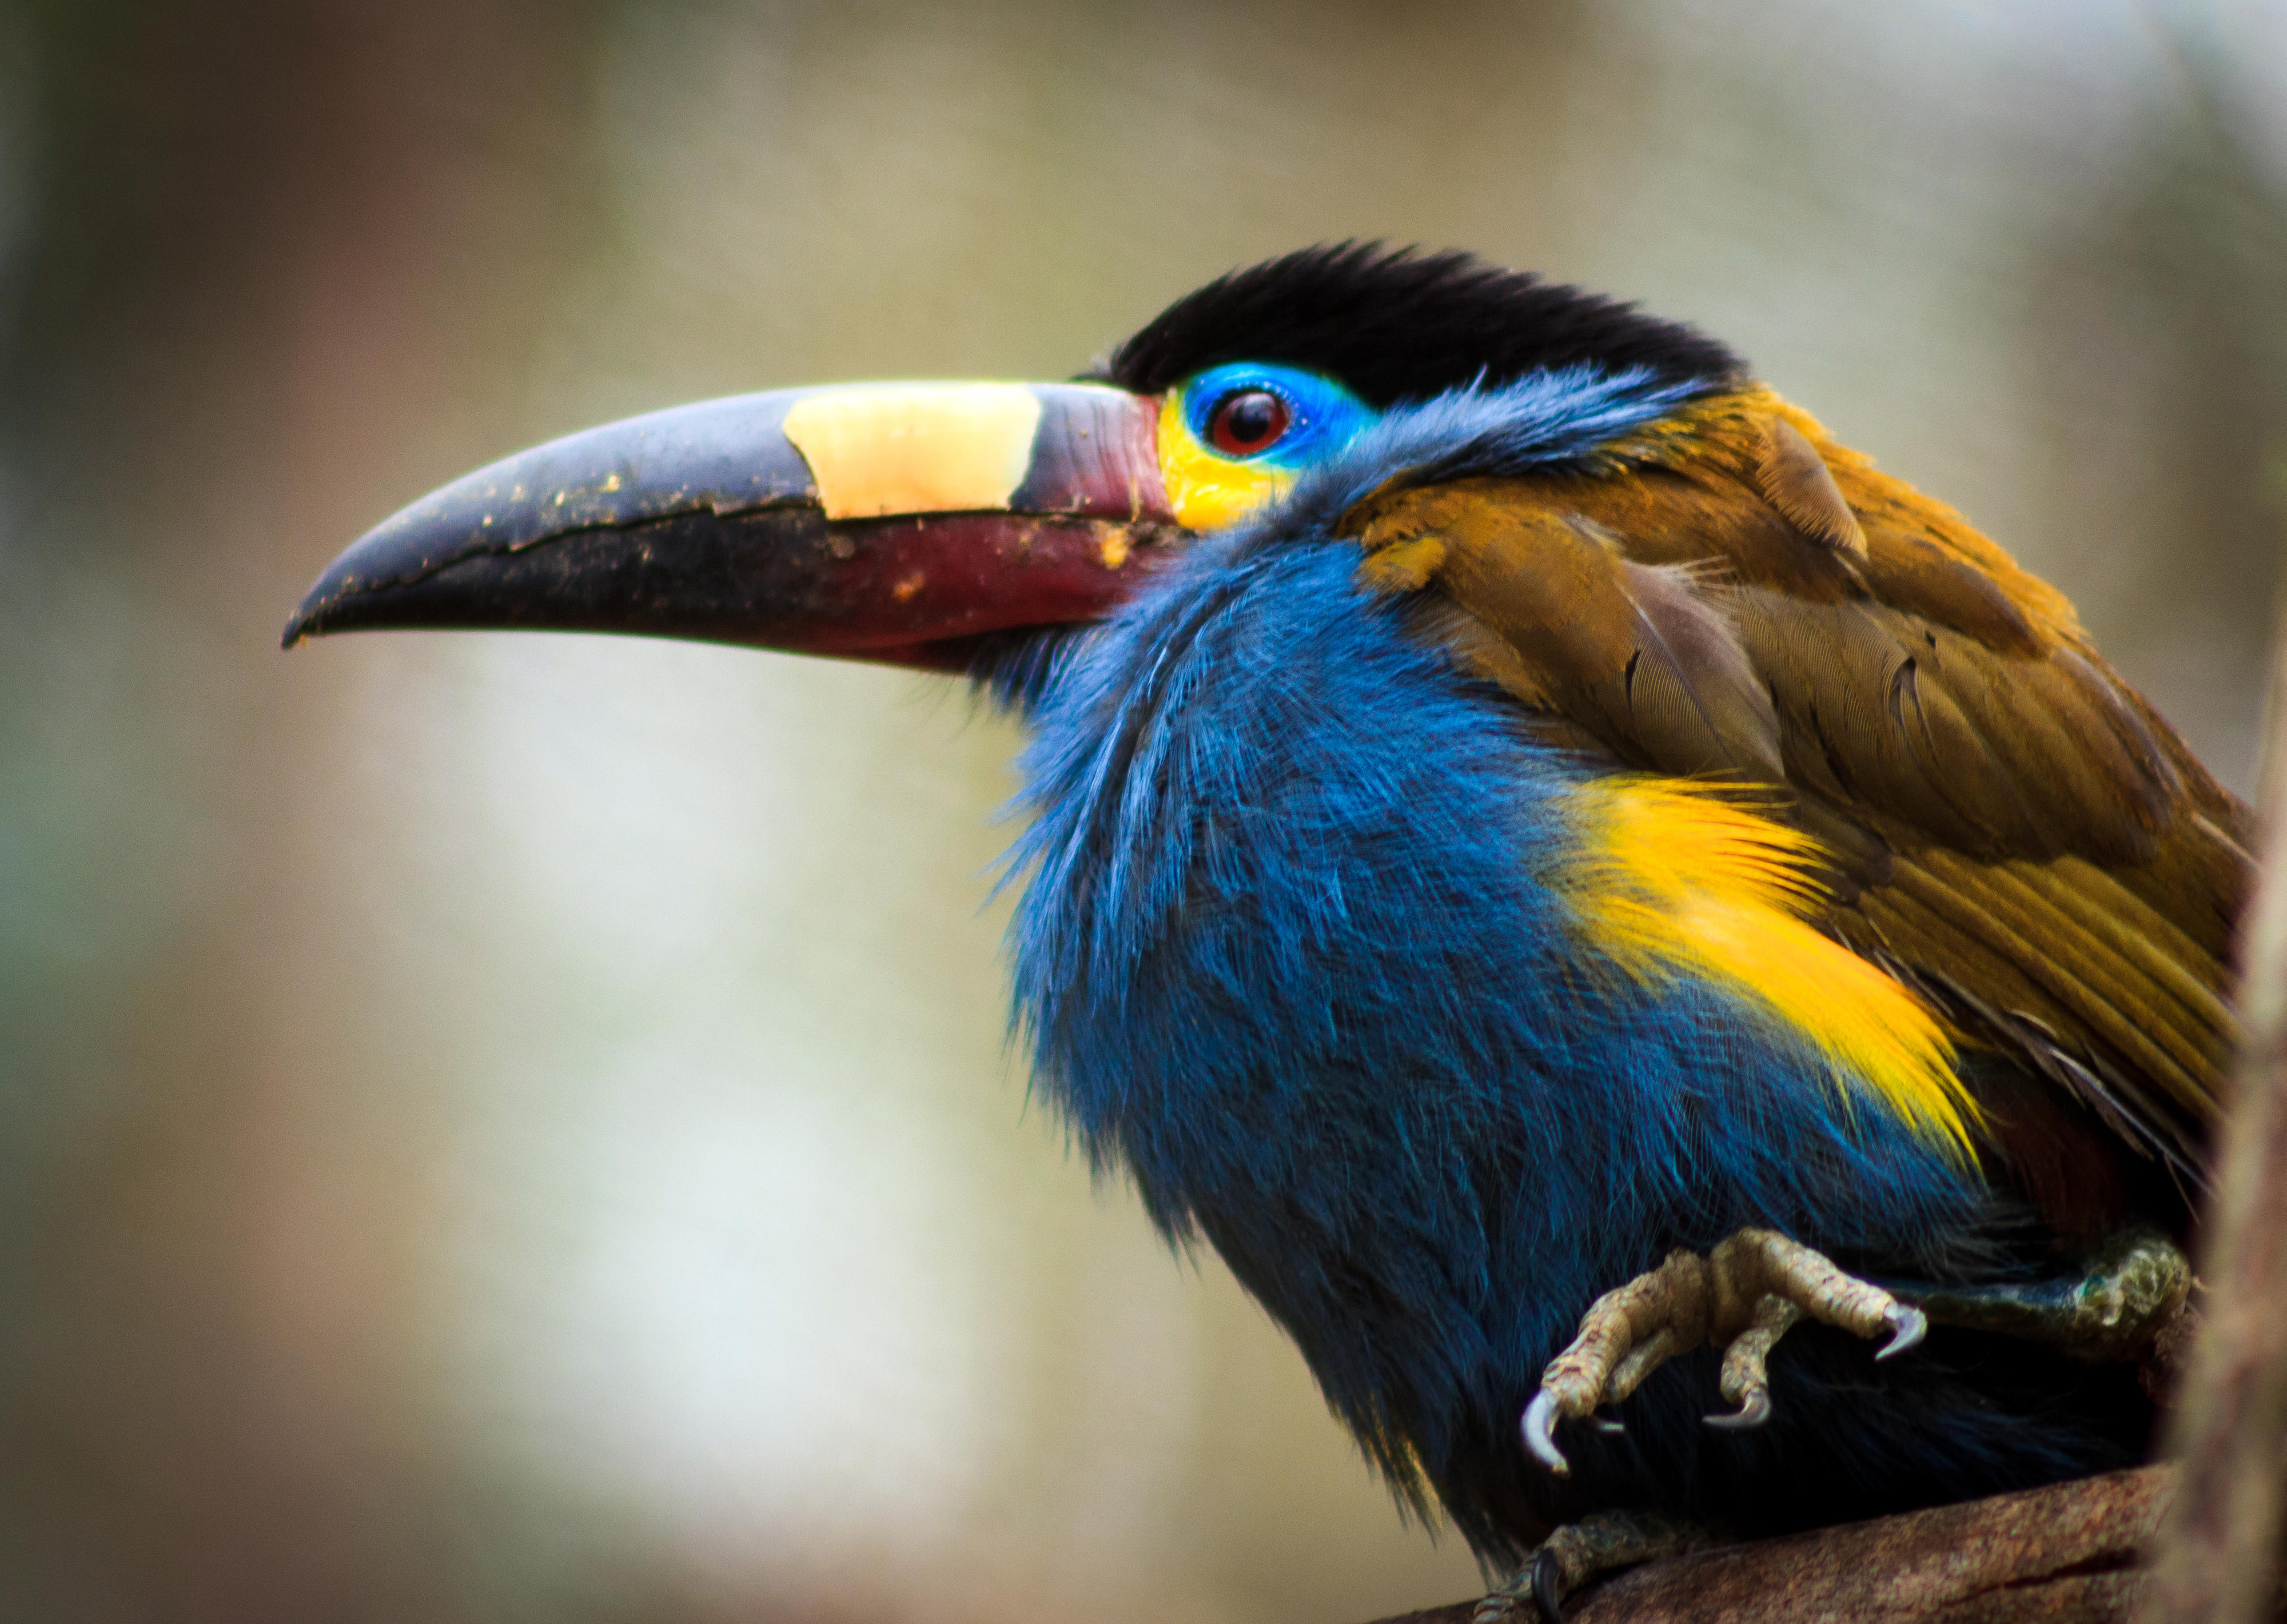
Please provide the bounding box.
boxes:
[1557,775,1976,1162]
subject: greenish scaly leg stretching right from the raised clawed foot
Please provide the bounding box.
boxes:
[1905,1228,2198,1386]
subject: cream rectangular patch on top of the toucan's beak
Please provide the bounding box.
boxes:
[784,384,1041,519]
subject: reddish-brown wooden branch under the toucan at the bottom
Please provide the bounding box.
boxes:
[1384,1466,2175,1624]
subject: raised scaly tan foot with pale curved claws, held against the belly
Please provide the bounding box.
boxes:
[1523,1228,1926,1473]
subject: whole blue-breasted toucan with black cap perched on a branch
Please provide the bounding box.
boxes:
[286,242,2250,1617]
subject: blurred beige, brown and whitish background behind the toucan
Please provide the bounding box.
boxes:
[0,0,2287,1624]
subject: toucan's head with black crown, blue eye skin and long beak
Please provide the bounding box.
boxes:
[286,245,1743,686]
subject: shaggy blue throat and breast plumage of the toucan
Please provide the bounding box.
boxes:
[997,377,2104,1555]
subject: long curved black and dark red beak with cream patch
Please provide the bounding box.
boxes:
[286,384,1182,670]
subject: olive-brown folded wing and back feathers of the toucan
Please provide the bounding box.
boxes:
[1342,389,2250,1180]
